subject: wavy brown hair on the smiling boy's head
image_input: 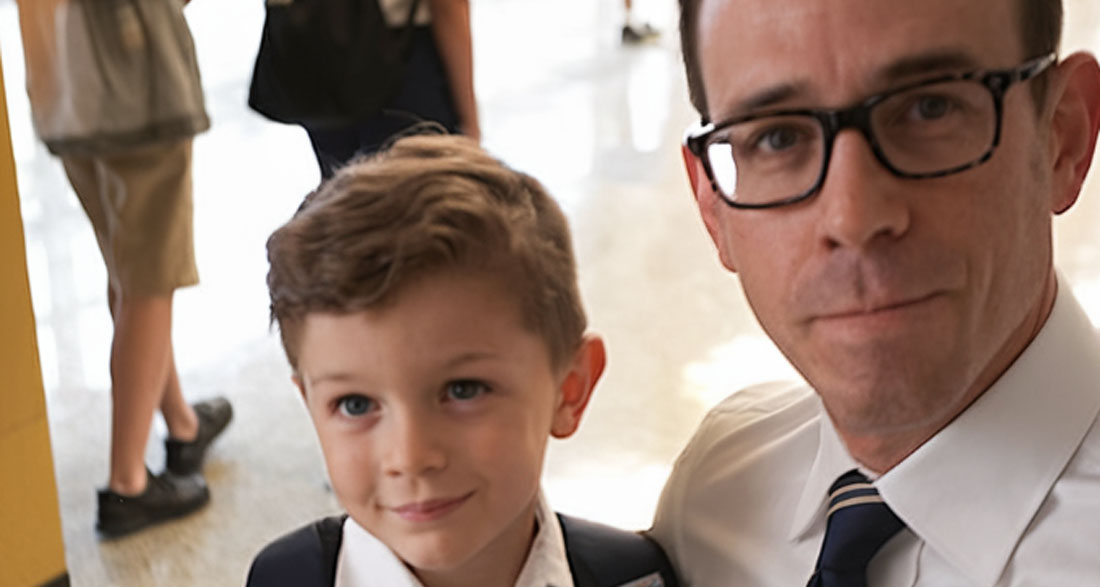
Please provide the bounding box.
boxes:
[267,135,586,370]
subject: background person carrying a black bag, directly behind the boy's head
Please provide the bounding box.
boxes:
[249,0,481,179]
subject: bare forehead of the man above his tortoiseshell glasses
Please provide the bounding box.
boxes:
[696,0,1022,119]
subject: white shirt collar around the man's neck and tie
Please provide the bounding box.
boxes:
[791,279,1100,586]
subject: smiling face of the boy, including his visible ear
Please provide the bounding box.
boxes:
[296,272,603,576]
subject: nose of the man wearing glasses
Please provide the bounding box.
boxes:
[817,129,911,248]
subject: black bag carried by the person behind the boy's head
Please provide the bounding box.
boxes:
[249,0,420,128]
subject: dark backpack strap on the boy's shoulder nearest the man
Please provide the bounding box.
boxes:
[558,513,680,587]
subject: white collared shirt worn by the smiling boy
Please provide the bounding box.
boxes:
[336,491,573,587]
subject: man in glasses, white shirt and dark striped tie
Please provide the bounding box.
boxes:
[655,0,1100,587]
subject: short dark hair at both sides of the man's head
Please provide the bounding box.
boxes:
[680,0,1063,119]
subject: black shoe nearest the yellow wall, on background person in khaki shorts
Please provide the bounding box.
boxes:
[96,470,210,538]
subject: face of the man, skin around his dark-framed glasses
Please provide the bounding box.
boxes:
[689,0,1052,433]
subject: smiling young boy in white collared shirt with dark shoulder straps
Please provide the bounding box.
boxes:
[249,136,675,587]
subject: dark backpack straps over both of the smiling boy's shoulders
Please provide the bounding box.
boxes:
[246,513,679,587]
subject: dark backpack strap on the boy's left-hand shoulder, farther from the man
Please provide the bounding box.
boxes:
[246,516,348,587]
